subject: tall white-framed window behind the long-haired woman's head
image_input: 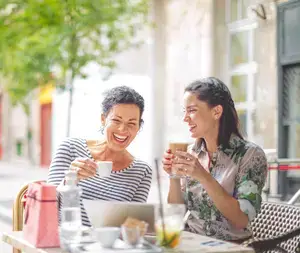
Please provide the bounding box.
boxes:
[226,0,257,140]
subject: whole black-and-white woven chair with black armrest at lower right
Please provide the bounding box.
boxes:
[243,202,300,253]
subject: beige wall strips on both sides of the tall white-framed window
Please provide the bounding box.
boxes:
[215,0,277,149]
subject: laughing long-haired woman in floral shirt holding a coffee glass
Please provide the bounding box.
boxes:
[163,77,267,241]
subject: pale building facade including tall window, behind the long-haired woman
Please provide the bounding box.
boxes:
[161,0,277,149]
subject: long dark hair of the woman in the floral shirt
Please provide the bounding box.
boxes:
[185,77,243,147]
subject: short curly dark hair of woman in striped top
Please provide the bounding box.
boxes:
[102,86,145,125]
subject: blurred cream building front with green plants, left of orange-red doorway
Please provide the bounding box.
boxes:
[0,87,41,165]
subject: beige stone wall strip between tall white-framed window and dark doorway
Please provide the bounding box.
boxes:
[254,1,278,149]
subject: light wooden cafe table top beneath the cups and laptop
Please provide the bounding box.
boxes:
[0,231,255,253]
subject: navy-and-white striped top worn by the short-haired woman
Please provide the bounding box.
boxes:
[47,138,152,226]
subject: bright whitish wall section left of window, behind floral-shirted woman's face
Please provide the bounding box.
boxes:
[165,0,214,145]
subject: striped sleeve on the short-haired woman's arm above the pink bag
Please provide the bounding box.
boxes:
[47,139,74,186]
